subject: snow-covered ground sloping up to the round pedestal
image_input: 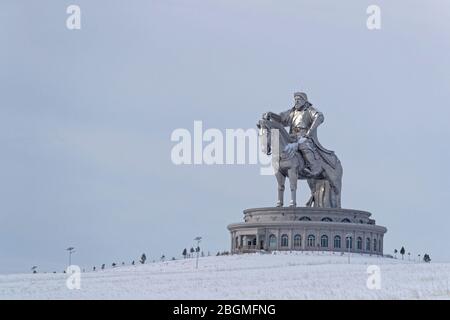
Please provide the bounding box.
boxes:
[0,252,450,299]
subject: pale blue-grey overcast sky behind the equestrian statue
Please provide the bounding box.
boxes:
[0,0,450,273]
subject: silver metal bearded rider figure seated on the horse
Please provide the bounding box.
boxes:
[263,92,324,177]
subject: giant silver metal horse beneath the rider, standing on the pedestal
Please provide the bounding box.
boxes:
[257,119,343,208]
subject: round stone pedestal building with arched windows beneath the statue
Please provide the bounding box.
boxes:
[228,207,387,255]
